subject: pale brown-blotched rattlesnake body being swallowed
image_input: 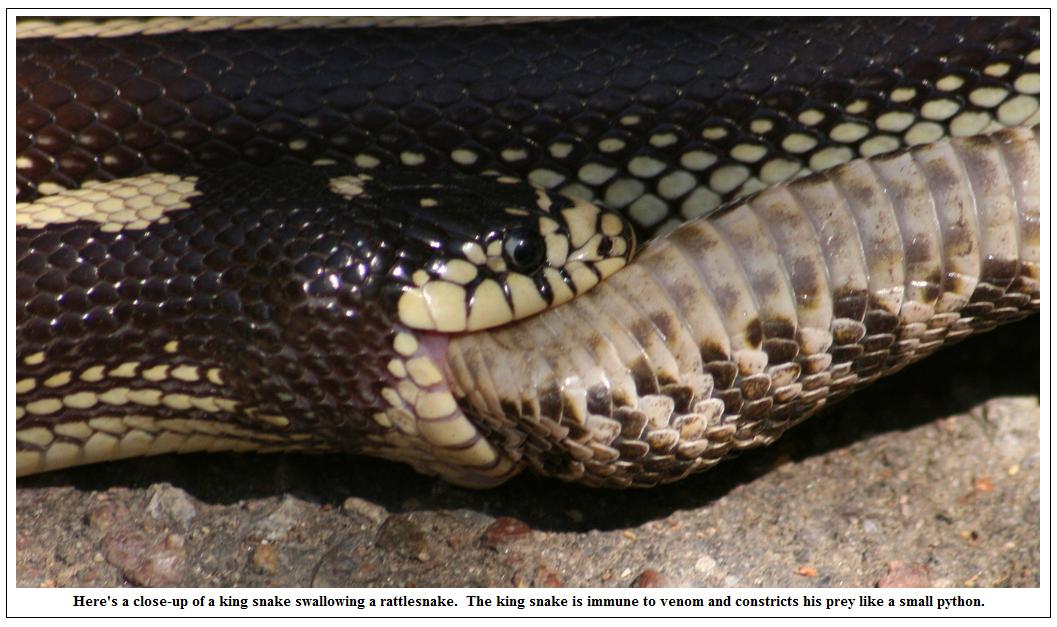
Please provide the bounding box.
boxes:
[448,127,1041,487]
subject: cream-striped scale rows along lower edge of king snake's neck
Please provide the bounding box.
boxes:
[15,340,328,476]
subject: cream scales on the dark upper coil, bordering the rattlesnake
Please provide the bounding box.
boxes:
[484,59,1041,232]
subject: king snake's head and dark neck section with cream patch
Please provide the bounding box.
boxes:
[16,166,634,482]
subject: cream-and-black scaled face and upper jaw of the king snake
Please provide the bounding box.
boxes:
[396,190,635,333]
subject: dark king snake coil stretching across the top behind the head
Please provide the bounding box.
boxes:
[16,17,1039,236]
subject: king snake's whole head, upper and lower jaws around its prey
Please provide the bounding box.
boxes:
[314,170,635,487]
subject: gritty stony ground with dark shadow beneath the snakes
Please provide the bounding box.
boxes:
[16,318,1040,587]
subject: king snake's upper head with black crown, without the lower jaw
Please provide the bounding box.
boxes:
[367,171,635,332]
